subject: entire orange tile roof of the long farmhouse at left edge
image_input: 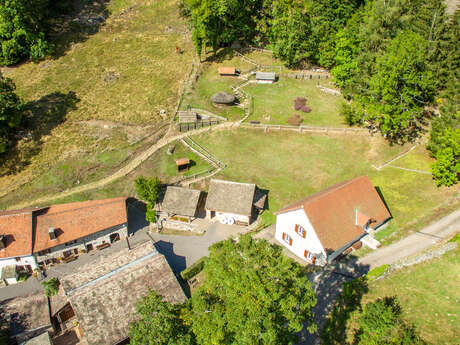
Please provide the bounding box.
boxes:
[0,198,127,258]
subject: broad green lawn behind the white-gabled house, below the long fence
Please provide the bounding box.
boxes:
[190,129,456,241]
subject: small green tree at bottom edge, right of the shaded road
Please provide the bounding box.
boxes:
[354,297,425,345]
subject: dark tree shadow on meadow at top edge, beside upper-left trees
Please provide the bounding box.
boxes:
[49,0,110,59]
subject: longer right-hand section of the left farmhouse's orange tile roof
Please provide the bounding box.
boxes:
[34,198,128,253]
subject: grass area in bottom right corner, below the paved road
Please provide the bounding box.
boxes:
[349,248,460,345]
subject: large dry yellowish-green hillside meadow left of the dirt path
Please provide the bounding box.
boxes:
[0,0,194,207]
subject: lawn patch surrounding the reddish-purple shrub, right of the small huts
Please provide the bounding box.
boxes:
[245,77,347,127]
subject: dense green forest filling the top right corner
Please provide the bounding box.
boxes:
[181,0,460,186]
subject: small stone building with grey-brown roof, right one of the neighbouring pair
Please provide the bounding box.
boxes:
[205,179,267,225]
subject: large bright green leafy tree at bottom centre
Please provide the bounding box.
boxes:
[184,235,316,345]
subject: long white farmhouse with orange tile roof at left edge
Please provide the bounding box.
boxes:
[0,198,128,271]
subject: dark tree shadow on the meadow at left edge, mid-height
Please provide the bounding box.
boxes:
[0,91,80,176]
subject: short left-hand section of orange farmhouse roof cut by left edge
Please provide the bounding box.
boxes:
[0,210,32,258]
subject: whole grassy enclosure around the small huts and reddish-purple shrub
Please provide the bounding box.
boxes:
[182,50,347,127]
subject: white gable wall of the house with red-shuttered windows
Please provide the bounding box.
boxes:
[275,209,326,261]
